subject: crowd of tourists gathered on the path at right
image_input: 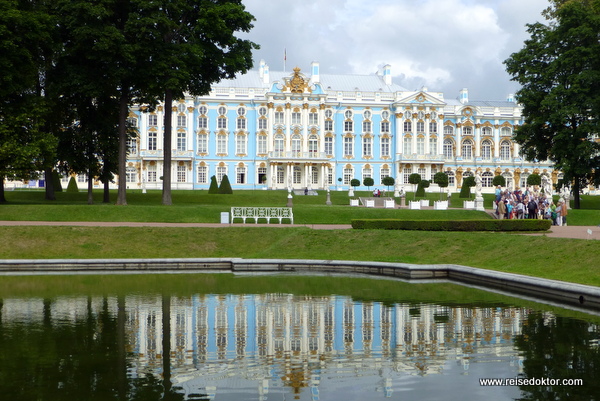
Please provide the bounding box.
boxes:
[494,185,569,226]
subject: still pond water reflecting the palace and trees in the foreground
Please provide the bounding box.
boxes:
[0,276,600,401]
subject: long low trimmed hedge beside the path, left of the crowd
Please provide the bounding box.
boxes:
[352,219,552,231]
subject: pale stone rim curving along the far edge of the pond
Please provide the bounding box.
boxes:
[0,258,600,310]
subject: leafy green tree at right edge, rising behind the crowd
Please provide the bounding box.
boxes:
[505,0,600,209]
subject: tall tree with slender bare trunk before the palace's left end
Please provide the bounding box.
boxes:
[140,0,258,205]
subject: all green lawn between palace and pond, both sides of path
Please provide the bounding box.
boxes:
[0,190,600,286]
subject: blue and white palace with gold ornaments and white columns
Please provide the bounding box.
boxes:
[127,61,560,192]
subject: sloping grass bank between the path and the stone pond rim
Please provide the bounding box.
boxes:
[0,226,600,286]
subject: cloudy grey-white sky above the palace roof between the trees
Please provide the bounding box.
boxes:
[243,0,549,100]
